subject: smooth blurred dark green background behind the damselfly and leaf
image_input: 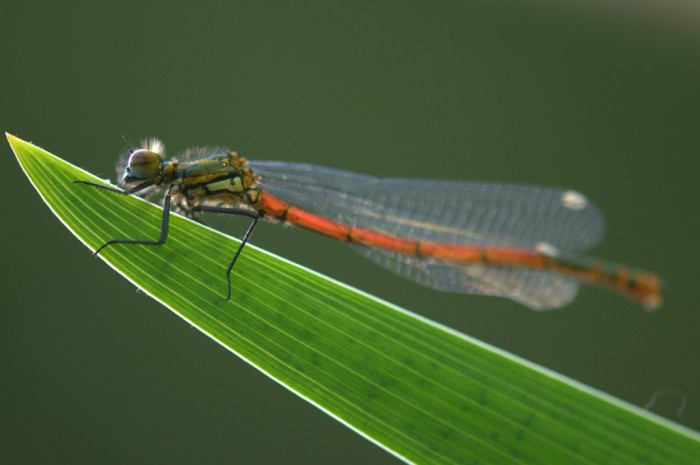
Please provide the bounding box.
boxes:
[0,0,700,464]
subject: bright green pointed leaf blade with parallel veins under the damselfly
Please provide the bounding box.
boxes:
[8,135,700,465]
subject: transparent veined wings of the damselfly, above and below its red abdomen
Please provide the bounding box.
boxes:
[249,161,604,309]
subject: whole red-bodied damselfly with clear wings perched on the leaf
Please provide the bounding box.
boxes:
[77,139,661,310]
